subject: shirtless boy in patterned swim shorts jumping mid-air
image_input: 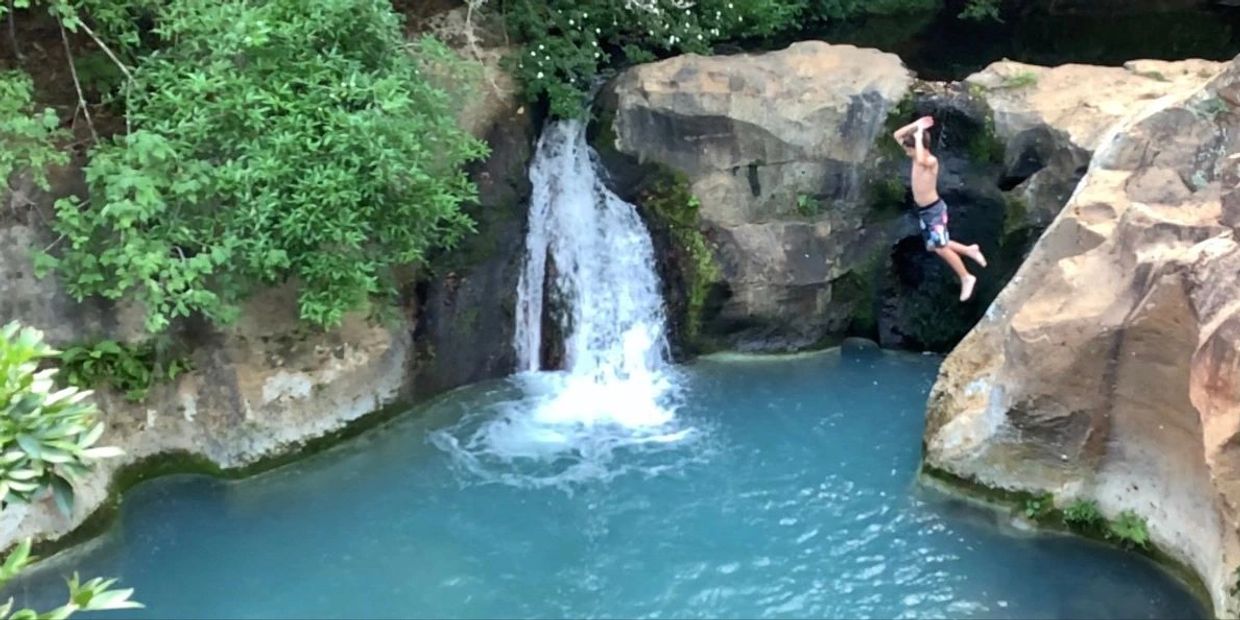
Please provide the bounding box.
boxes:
[893,117,986,301]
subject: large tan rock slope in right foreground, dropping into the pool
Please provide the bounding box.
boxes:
[925,60,1240,616]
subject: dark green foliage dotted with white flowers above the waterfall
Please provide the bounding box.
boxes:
[503,0,935,118]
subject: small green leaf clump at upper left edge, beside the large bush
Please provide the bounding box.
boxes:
[0,71,68,190]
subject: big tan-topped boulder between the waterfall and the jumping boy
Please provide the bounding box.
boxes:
[614,42,913,348]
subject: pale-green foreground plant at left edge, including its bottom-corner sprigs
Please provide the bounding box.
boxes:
[0,322,141,620]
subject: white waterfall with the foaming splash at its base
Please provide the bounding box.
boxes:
[432,122,693,486]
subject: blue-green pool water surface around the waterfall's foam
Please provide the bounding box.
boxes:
[10,351,1205,619]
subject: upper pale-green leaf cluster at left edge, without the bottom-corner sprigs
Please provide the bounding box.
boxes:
[0,322,120,511]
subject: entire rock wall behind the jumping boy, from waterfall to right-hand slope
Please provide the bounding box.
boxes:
[596,41,1216,351]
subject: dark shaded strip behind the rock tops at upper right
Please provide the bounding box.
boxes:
[780,6,1240,81]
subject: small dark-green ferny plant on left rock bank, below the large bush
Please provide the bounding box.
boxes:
[60,340,192,402]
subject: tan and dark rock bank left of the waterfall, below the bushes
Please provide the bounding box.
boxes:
[0,10,533,548]
